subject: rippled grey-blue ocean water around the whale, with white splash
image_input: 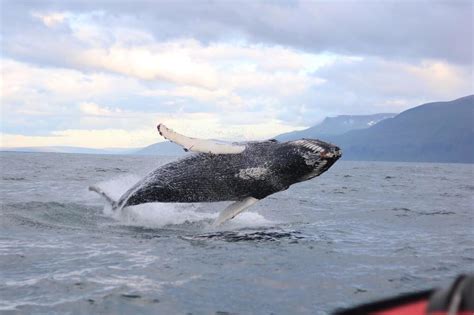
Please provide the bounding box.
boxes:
[0,152,474,315]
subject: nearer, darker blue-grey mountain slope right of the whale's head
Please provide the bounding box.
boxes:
[326,95,474,163]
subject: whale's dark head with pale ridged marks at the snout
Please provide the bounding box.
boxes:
[289,139,342,180]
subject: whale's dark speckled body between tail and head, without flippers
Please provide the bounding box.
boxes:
[119,140,312,207]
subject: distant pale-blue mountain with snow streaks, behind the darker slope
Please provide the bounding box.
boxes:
[276,113,397,141]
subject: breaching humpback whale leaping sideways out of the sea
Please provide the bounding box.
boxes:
[89,124,342,225]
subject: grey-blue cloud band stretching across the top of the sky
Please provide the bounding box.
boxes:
[5,0,474,64]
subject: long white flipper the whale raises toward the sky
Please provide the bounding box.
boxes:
[157,124,245,154]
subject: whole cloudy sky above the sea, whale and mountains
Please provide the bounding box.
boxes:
[0,0,474,148]
